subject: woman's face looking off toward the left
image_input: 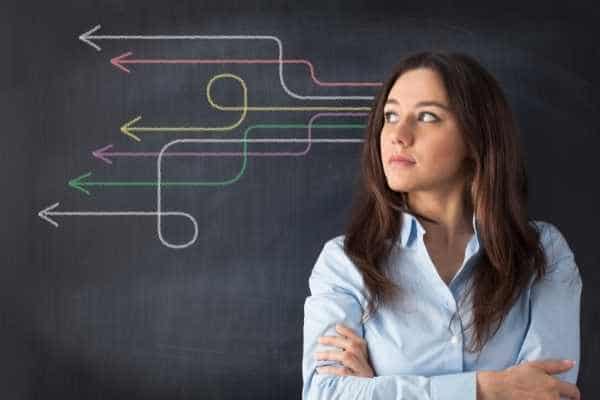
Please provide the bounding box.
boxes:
[380,68,467,197]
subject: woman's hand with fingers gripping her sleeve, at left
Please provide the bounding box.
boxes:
[315,324,375,378]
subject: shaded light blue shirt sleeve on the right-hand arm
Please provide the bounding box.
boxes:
[517,223,582,384]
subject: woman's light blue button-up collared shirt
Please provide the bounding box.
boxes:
[302,212,582,400]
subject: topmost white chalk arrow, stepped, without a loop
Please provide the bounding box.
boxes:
[78,25,373,100]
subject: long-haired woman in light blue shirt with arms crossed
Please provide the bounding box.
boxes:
[302,52,582,400]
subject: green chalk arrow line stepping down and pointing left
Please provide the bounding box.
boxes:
[68,124,365,195]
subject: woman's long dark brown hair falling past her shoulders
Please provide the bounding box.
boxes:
[344,52,546,351]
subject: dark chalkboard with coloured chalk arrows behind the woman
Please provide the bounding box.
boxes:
[0,0,600,399]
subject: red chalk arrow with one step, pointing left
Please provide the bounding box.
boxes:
[110,51,382,86]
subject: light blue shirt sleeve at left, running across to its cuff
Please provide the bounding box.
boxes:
[302,237,476,400]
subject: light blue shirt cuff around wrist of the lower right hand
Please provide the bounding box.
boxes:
[431,371,477,400]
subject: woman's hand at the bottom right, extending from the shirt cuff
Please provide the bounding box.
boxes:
[477,360,581,400]
